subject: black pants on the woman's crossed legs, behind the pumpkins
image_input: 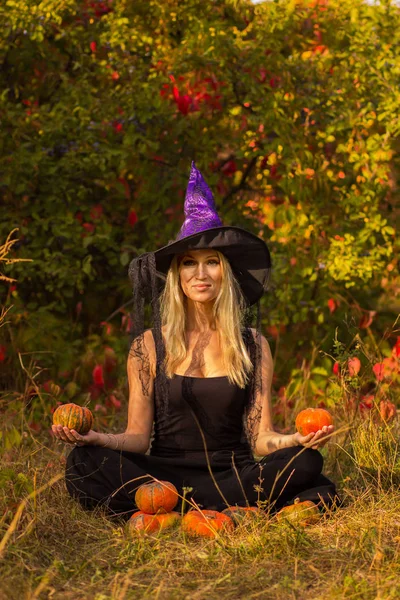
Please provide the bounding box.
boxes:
[66,446,339,518]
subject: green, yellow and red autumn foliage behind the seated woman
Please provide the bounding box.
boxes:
[0,0,400,427]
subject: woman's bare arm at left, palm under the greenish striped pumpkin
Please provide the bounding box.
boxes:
[53,331,155,454]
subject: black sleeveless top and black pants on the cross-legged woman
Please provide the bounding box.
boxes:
[66,375,338,518]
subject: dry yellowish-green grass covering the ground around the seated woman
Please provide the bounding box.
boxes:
[0,424,400,600]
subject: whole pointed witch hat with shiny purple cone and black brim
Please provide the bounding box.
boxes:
[131,162,271,305]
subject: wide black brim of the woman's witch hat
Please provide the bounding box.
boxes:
[154,226,271,306]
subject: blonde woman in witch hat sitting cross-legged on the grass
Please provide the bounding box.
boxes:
[53,164,337,518]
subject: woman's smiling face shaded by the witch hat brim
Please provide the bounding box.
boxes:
[179,249,222,302]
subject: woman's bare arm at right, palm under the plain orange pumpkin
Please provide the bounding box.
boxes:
[249,332,334,456]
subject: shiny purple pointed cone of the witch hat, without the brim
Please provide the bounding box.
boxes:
[177,161,222,240]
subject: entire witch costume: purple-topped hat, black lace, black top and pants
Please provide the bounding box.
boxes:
[66,163,338,518]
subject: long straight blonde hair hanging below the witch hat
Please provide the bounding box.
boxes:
[161,252,253,388]
